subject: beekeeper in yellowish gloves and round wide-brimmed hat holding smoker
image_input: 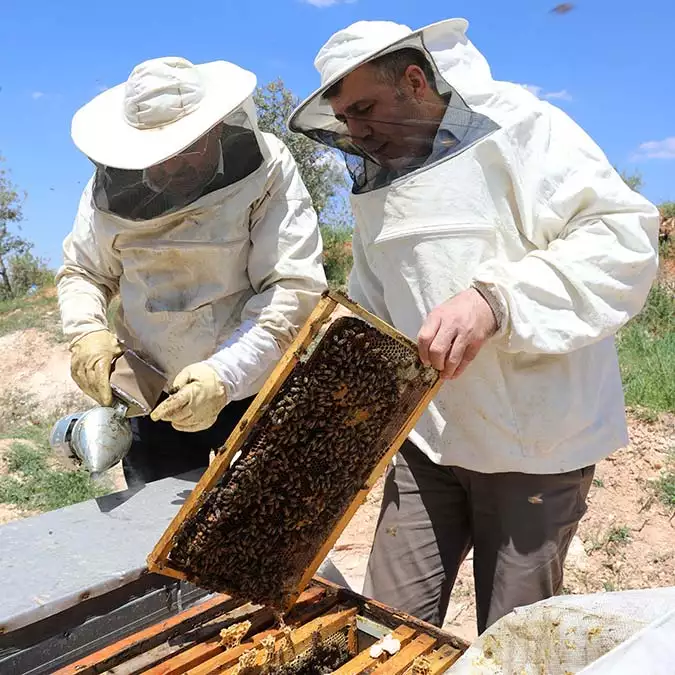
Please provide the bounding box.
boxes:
[57,58,326,483]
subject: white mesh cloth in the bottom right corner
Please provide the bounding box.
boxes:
[446,587,675,675]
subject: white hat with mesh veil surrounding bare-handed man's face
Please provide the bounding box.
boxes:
[288,19,497,194]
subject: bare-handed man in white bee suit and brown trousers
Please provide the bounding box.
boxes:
[289,19,658,632]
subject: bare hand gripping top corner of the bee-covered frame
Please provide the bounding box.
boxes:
[417,288,497,380]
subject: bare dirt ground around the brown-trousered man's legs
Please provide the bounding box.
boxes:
[331,414,675,640]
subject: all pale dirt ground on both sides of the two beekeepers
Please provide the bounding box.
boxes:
[0,329,675,639]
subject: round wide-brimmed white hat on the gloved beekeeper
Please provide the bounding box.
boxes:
[71,57,256,170]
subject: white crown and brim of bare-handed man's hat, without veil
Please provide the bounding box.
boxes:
[288,18,469,132]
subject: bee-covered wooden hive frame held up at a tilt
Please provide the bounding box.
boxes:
[148,293,440,611]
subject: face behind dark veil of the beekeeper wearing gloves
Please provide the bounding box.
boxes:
[145,125,221,197]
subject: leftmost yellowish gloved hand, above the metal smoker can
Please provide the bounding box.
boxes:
[70,330,124,406]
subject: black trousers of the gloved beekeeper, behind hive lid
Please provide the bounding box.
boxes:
[122,396,253,487]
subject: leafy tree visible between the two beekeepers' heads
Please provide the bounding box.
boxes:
[253,78,345,223]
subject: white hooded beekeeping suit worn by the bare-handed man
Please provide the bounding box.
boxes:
[289,19,658,474]
